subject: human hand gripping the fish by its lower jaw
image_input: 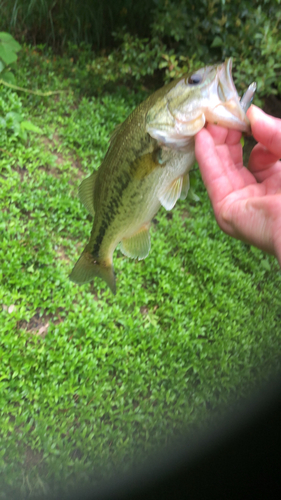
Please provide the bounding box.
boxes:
[195,106,281,266]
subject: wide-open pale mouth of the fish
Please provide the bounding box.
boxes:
[214,58,256,133]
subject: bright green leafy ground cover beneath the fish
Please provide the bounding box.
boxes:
[0,49,281,498]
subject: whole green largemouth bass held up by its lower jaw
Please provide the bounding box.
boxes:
[69,58,256,294]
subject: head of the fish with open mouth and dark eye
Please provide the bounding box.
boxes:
[146,59,256,151]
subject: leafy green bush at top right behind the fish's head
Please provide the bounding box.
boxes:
[86,0,281,104]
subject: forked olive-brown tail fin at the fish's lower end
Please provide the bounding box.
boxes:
[69,250,116,295]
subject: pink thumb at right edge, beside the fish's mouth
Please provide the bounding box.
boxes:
[247,105,281,159]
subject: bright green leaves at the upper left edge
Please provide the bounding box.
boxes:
[0,32,21,83]
